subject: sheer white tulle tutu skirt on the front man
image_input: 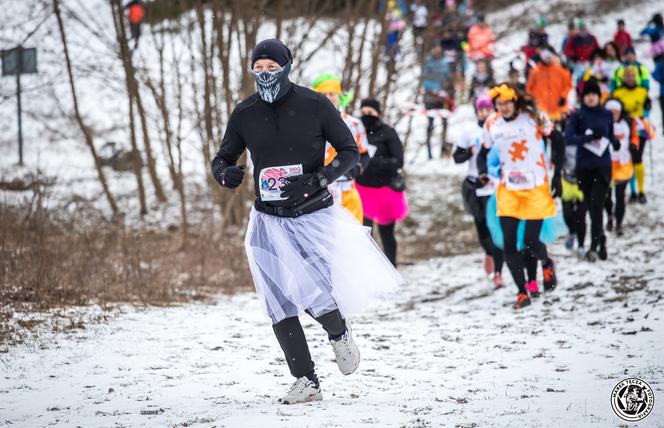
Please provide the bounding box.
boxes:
[245,204,404,324]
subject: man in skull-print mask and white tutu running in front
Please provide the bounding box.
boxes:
[212,39,402,404]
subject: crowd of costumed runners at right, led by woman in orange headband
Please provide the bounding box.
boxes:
[454,14,664,309]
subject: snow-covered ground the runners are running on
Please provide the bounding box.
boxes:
[0,2,664,427]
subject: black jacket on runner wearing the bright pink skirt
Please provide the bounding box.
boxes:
[355,121,403,187]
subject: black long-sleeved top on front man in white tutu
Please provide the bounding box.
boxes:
[212,84,360,212]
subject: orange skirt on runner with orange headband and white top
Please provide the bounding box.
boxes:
[496,183,556,220]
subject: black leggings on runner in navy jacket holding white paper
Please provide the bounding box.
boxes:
[576,166,611,251]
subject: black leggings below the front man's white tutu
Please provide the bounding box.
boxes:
[272,309,346,379]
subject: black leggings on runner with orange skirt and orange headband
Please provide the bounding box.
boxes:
[500,217,549,294]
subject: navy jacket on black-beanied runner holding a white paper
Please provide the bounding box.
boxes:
[565,106,615,169]
